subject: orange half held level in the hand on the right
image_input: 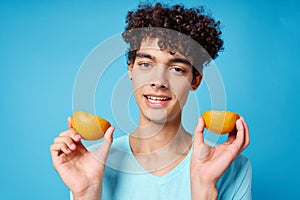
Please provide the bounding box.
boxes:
[202,110,240,134]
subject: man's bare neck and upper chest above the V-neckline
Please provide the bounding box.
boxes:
[130,112,192,176]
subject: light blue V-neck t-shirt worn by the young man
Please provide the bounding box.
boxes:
[71,135,252,200]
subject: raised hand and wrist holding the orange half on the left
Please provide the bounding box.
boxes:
[50,117,114,200]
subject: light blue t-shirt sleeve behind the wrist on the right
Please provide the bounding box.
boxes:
[217,155,252,200]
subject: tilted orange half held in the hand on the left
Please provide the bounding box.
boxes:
[72,111,110,140]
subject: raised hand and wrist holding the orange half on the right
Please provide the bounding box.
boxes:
[190,117,249,200]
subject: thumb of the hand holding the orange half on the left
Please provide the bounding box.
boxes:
[93,126,115,164]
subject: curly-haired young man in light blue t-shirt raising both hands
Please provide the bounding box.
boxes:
[50,3,251,200]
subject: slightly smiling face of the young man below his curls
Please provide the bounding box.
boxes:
[128,39,201,123]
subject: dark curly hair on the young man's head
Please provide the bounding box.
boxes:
[122,3,223,74]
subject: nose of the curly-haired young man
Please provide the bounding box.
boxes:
[150,66,169,88]
